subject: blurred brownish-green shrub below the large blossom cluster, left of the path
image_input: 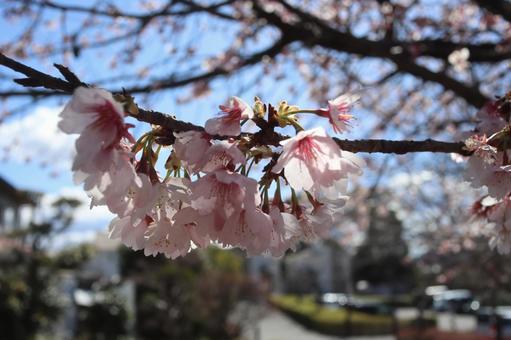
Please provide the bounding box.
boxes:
[122,248,257,339]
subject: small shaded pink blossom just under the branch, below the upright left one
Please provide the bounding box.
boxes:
[201,140,245,172]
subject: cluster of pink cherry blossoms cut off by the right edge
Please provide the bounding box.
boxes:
[465,93,511,253]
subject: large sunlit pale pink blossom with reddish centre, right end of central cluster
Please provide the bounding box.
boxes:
[272,128,364,196]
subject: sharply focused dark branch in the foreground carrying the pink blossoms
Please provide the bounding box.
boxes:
[0,54,469,155]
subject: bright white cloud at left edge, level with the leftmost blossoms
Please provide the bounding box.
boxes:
[0,106,76,172]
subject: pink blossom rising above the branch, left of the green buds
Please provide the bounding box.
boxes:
[205,97,254,136]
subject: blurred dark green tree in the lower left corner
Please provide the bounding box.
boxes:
[0,198,80,339]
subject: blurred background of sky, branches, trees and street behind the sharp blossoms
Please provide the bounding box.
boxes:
[0,0,511,339]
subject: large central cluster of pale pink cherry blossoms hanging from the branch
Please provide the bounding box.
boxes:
[59,87,365,258]
